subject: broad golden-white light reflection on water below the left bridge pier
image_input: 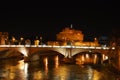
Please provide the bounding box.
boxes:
[9,60,28,80]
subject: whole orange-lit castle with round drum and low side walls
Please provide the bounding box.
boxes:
[48,25,99,46]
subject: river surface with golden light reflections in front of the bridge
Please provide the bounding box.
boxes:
[0,55,118,80]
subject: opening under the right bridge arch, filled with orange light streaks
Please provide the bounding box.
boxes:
[72,51,103,64]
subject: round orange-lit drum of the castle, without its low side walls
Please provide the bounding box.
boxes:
[57,27,84,45]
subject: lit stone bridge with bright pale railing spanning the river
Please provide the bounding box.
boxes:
[0,45,114,58]
